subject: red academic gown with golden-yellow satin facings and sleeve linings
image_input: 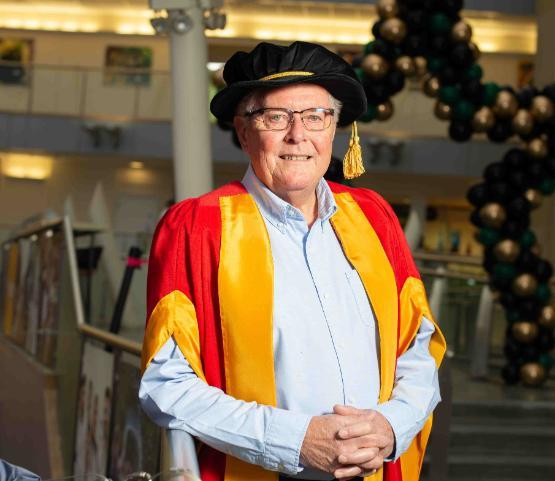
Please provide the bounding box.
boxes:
[142,182,445,481]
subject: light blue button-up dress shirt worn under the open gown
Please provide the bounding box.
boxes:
[139,167,440,480]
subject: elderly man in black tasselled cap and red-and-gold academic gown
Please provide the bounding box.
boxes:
[139,42,444,481]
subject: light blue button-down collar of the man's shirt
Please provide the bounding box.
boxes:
[241,164,337,230]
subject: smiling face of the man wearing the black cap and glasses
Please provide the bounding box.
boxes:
[235,84,335,199]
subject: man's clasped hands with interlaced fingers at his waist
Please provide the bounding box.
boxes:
[301,405,395,480]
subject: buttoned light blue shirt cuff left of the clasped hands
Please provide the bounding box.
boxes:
[263,408,311,475]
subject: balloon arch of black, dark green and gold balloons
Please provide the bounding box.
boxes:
[353,0,555,386]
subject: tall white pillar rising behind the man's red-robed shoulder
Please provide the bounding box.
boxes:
[168,2,212,201]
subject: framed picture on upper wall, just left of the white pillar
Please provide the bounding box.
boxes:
[104,46,152,87]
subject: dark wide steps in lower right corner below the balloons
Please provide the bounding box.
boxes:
[446,399,555,481]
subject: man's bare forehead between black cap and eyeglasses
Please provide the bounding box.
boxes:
[260,84,330,110]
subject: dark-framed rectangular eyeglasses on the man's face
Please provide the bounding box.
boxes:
[245,107,335,131]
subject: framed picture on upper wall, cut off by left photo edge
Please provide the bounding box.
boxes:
[0,37,33,85]
